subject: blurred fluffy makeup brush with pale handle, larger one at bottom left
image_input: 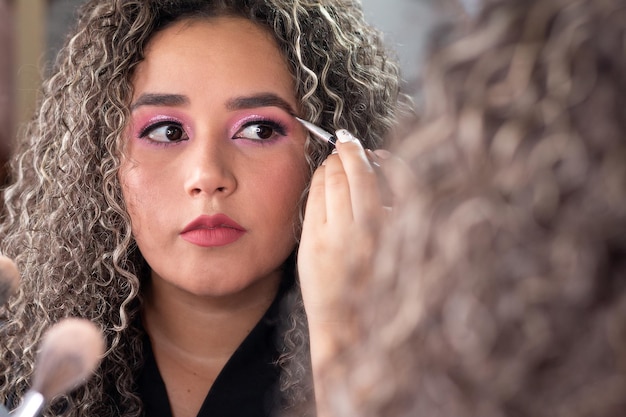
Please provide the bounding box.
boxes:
[12,318,104,417]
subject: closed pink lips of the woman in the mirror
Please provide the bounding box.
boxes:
[180,214,246,247]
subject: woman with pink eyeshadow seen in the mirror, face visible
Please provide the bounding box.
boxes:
[0,0,398,417]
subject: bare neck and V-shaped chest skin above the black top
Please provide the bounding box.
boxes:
[143,271,281,417]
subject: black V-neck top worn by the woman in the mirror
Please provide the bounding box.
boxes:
[137,285,286,417]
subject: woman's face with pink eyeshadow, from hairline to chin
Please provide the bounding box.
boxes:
[120,17,309,296]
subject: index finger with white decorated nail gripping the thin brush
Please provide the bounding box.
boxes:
[336,130,383,222]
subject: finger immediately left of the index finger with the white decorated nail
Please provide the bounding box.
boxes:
[324,155,353,224]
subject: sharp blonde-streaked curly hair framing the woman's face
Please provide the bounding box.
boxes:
[0,0,399,416]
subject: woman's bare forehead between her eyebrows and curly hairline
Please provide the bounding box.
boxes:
[132,17,295,100]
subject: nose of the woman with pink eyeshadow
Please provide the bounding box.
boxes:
[183,138,237,197]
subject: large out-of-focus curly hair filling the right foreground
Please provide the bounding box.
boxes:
[325,0,626,417]
